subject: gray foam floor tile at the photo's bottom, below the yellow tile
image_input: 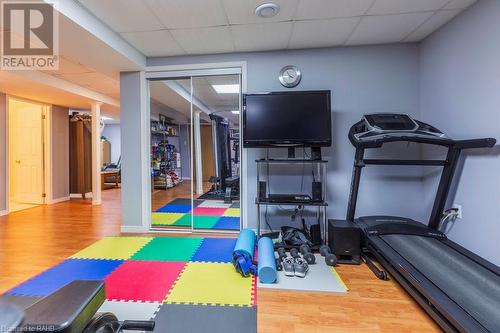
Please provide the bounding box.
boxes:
[154,304,257,333]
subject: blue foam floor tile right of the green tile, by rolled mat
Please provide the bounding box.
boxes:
[191,238,236,262]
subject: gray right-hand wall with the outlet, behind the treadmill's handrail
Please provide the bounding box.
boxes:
[420,0,500,265]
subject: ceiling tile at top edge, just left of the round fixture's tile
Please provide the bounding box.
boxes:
[145,0,227,29]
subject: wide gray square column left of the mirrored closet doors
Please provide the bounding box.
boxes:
[120,72,151,232]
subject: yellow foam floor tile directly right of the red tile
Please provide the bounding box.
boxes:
[165,262,255,306]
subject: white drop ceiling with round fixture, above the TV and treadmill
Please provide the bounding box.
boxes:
[79,0,476,56]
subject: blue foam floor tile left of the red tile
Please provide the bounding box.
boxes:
[5,259,124,296]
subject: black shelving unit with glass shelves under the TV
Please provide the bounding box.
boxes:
[255,159,328,244]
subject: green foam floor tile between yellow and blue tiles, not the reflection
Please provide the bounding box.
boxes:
[131,237,203,261]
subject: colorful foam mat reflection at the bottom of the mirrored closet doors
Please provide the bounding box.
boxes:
[152,198,240,230]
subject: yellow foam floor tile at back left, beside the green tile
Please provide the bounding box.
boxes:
[71,237,153,260]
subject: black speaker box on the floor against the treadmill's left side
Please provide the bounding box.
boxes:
[328,220,361,265]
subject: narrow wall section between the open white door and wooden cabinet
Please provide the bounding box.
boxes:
[51,105,69,200]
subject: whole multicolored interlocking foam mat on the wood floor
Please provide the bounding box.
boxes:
[0,237,257,333]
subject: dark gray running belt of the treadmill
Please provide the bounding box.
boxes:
[381,235,500,332]
